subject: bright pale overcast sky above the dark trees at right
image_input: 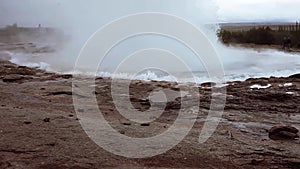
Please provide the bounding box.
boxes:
[217,0,300,21]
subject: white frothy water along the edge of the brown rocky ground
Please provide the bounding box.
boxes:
[2,43,300,83]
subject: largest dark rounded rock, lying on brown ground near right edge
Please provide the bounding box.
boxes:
[269,126,299,140]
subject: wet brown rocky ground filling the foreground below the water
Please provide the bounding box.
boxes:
[0,48,300,169]
